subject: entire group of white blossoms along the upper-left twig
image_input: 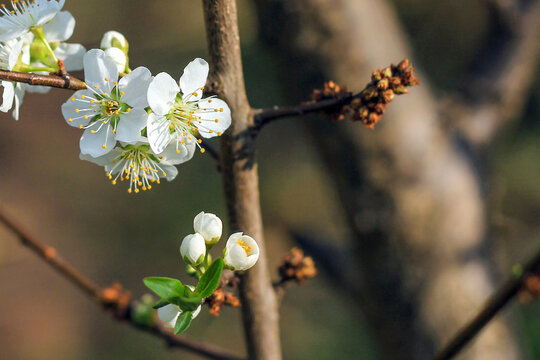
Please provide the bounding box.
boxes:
[0,0,231,193]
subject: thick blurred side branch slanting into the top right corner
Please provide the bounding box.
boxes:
[452,0,540,145]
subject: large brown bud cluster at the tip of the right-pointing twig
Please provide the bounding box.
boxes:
[349,59,420,128]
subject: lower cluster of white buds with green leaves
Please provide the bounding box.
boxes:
[144,212,259,334]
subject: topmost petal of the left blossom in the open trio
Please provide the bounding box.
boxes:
[83,49,118,93]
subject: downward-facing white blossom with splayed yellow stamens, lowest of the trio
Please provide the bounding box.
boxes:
[80,142,195,194]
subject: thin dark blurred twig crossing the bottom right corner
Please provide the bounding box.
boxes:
[433,249,540,360]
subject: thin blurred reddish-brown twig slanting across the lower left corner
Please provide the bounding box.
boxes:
[0,209,242,360]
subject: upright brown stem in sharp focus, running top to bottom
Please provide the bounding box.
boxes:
[203,0,281,360]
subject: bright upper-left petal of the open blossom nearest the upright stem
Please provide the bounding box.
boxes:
[147,73,180,115]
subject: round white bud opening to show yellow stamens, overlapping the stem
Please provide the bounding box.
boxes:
[223,232,259,270]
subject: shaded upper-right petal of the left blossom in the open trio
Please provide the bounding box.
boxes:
[118,66,152,108]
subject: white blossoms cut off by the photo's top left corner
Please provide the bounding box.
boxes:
[0,0,86,120]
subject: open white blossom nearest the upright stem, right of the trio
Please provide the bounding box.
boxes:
[148,58,231,153]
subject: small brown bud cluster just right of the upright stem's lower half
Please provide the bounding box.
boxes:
[278,248,317,284]
